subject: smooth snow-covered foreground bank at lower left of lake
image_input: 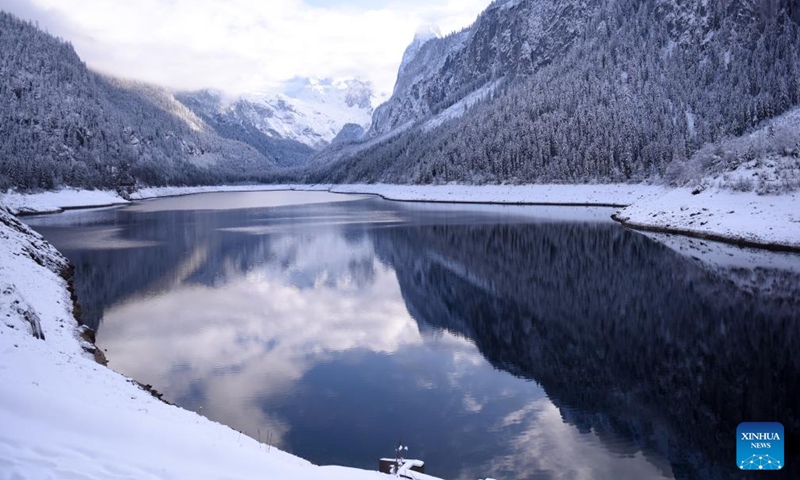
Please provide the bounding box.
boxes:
[0,209,433,480]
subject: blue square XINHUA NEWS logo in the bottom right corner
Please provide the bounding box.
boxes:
[736,423,784,471]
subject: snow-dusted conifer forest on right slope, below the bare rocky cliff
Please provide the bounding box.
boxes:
[309,0,800,183]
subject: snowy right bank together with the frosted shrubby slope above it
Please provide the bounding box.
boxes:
[617,108,800,251]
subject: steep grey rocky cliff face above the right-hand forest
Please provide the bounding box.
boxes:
[372,0,598,135]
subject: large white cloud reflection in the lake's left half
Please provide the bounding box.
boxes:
[99,232,424,445]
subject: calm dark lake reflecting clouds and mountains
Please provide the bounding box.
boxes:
[26,192,800,479]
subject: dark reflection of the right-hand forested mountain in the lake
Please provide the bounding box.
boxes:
[379,225,800,478]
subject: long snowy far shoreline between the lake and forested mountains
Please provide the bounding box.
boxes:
[0,184,800,252]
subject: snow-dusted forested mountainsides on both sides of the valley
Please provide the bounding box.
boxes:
[0,0,800,190]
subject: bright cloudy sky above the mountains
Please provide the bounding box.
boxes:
[0,0,490,96]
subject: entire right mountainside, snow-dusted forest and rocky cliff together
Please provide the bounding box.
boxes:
[307,0,800,183]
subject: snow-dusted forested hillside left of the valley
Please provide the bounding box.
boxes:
[0,12,275,190]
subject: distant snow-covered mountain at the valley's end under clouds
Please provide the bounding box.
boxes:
[176,79,373,166]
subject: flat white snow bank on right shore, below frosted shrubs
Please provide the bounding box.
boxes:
[616,188,800,251]
